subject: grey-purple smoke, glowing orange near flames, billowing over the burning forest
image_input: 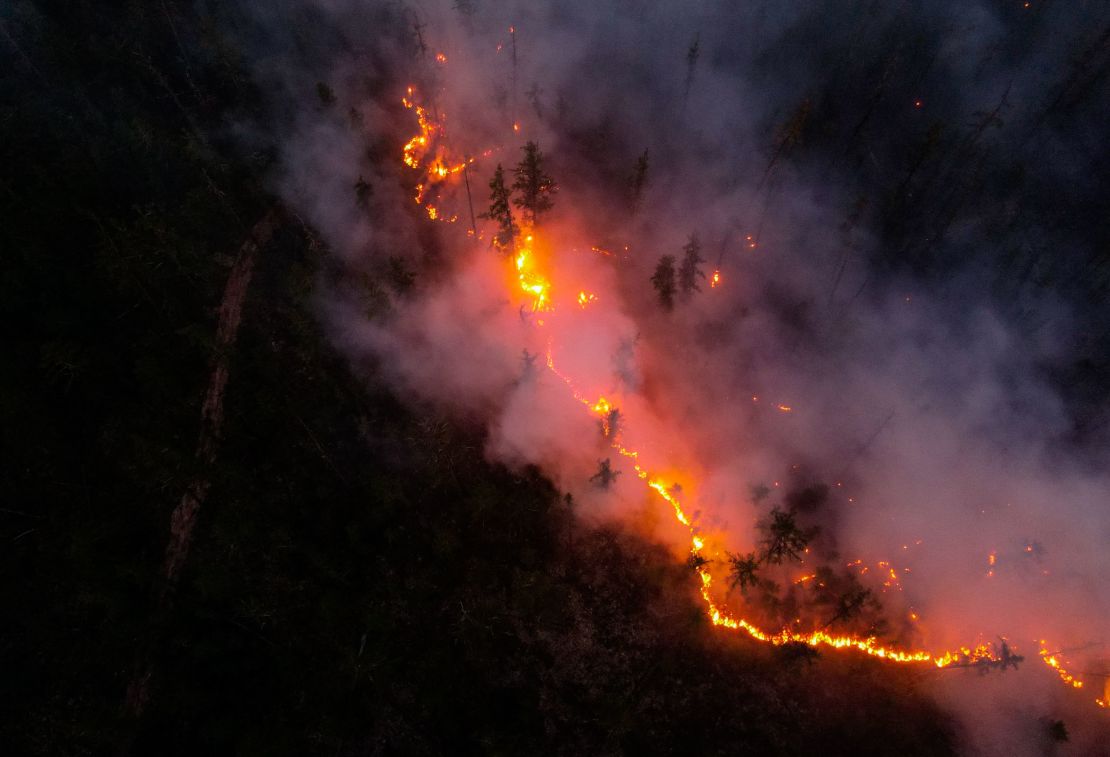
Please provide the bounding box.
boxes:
[234,0,1110,754]
